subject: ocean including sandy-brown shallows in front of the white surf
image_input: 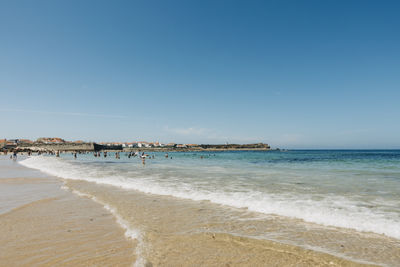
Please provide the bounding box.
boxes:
[20,150,400,266]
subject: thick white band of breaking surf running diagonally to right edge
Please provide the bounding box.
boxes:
[20,156,400,242]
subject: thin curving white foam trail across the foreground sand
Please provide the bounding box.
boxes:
[61,183,146,267]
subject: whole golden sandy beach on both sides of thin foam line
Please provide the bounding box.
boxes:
[0,157,384,266]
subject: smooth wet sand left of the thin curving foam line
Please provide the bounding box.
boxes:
[0,158,135,266]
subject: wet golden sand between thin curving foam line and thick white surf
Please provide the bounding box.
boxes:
[66,180,382,266]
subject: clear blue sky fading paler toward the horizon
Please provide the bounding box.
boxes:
[0,0,400,149]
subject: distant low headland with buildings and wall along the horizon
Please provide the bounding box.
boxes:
[0,137,271,151]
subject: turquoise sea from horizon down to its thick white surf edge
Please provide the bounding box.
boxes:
[21,150,400,239]
